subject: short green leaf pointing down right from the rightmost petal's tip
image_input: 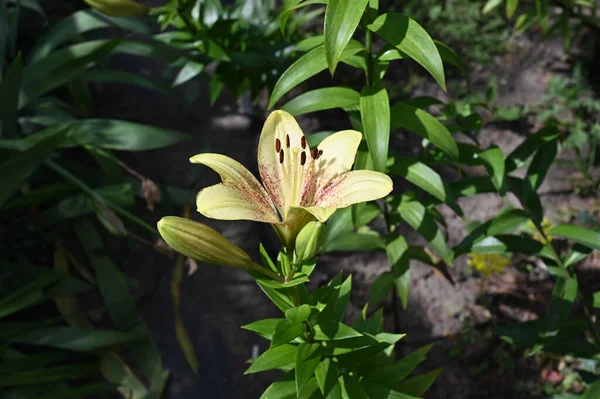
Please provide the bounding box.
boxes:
[388,157,446,202]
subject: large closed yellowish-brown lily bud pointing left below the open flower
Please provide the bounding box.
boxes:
[157,216,252,269]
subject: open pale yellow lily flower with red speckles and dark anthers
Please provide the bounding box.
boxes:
[190,111,392,248]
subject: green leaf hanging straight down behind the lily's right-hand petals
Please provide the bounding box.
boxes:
[360,87,390,172]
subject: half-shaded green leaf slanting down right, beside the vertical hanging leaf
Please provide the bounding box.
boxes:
[391,104,459,159]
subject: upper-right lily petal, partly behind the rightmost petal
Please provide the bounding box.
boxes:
[313,130,362,197]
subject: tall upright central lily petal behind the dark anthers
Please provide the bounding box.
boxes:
[258,111,310,218]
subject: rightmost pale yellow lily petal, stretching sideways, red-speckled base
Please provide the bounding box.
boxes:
[313,170,393,211]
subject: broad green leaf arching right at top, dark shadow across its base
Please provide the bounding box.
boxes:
[368,12,446,91]
